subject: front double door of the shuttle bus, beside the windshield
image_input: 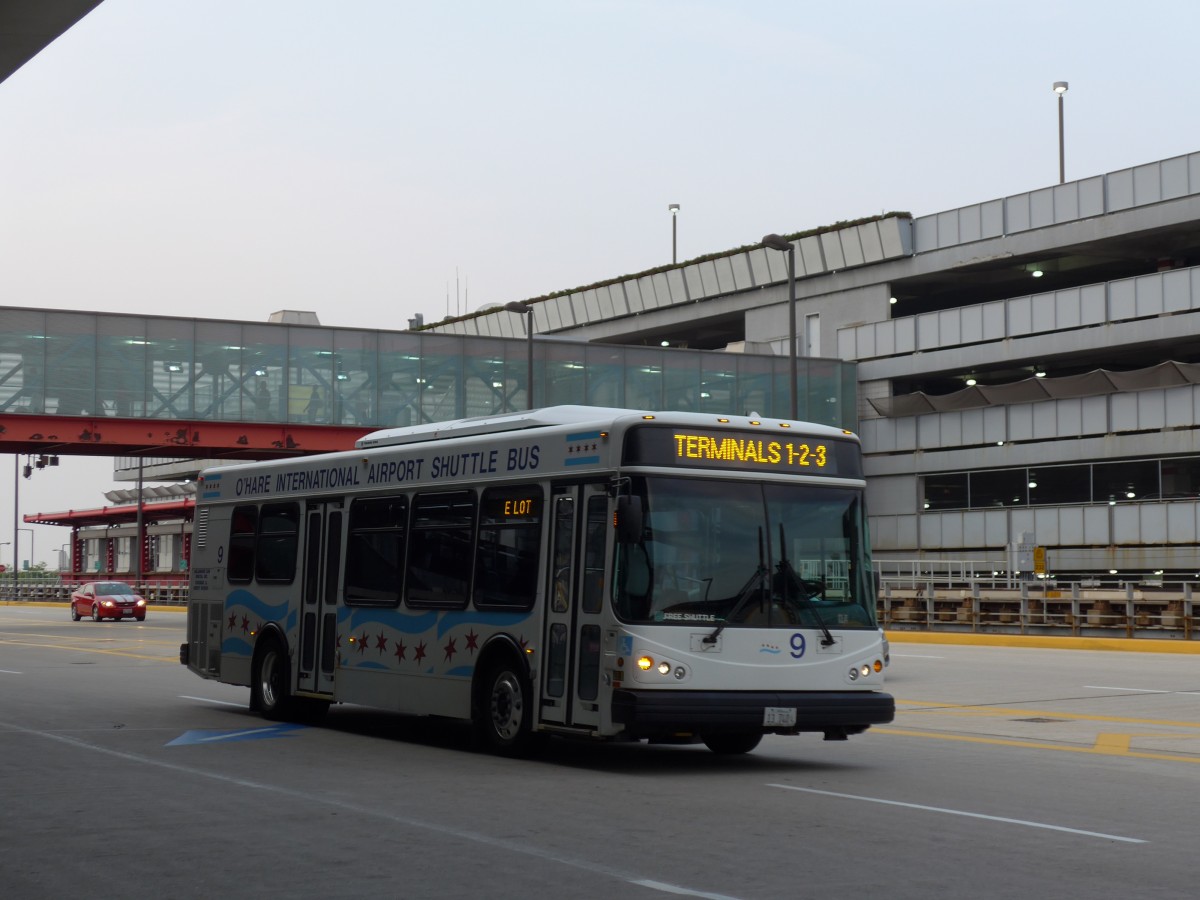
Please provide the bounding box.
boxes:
[540,485,610,727]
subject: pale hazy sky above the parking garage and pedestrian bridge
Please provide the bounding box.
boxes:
[0,0,1200,562]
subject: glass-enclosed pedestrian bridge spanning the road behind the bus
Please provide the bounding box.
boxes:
[0,307,857,452]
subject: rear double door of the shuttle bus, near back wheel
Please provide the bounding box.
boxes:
[296,500,346,695]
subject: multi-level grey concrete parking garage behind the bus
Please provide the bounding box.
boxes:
[444,154,1200,583]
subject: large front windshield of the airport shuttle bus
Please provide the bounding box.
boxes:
[614,476,876,630]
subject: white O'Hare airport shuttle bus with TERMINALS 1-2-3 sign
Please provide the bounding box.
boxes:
[180,407,895,754]
